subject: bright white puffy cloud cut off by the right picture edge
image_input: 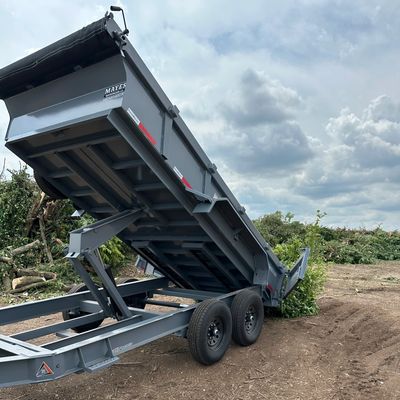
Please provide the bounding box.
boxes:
[293,96,400,223]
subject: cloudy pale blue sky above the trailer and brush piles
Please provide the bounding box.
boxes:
[0,0,400,230]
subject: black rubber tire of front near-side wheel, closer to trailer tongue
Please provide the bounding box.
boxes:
[187,299,232,365]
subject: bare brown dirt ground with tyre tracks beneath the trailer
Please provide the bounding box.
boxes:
[0,263,400,400]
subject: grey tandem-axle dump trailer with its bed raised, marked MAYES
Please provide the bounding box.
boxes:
[0,7,309,387]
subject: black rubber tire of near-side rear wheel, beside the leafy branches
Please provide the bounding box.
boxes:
[231,289,264,346]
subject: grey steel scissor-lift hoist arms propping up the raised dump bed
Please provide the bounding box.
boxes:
[66,209,145,319]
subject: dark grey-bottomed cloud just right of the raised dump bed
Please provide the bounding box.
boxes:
[207,69,312,175]
